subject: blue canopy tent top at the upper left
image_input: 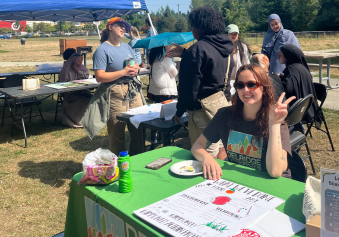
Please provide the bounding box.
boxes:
[0,0,157,36]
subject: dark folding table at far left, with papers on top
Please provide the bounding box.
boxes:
[0,84,99,148]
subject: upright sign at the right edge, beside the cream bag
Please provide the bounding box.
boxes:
[320,168,339,237]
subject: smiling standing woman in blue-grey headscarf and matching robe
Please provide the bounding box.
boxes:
[261,14,300,74]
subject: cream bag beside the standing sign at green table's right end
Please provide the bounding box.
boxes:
[303,176,321,222]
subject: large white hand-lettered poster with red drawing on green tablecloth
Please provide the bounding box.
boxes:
[134,179,285,237]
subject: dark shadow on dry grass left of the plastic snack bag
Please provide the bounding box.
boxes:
[18,161,82,188]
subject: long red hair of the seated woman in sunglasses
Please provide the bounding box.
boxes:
[228,64,274,139]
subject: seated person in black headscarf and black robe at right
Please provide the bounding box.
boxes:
[279,44,318,122]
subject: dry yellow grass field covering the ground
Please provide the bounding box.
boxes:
[0,38,339,237]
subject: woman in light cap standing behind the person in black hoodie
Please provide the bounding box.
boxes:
[225,24,251,101]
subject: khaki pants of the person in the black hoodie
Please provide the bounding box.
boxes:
[188,109,221,157]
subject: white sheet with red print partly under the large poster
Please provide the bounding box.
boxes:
[232,209,305,237]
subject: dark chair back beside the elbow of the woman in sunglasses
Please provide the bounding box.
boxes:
[288,150,307,183]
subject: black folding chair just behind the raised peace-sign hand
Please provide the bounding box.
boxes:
[285,95,315,174]
